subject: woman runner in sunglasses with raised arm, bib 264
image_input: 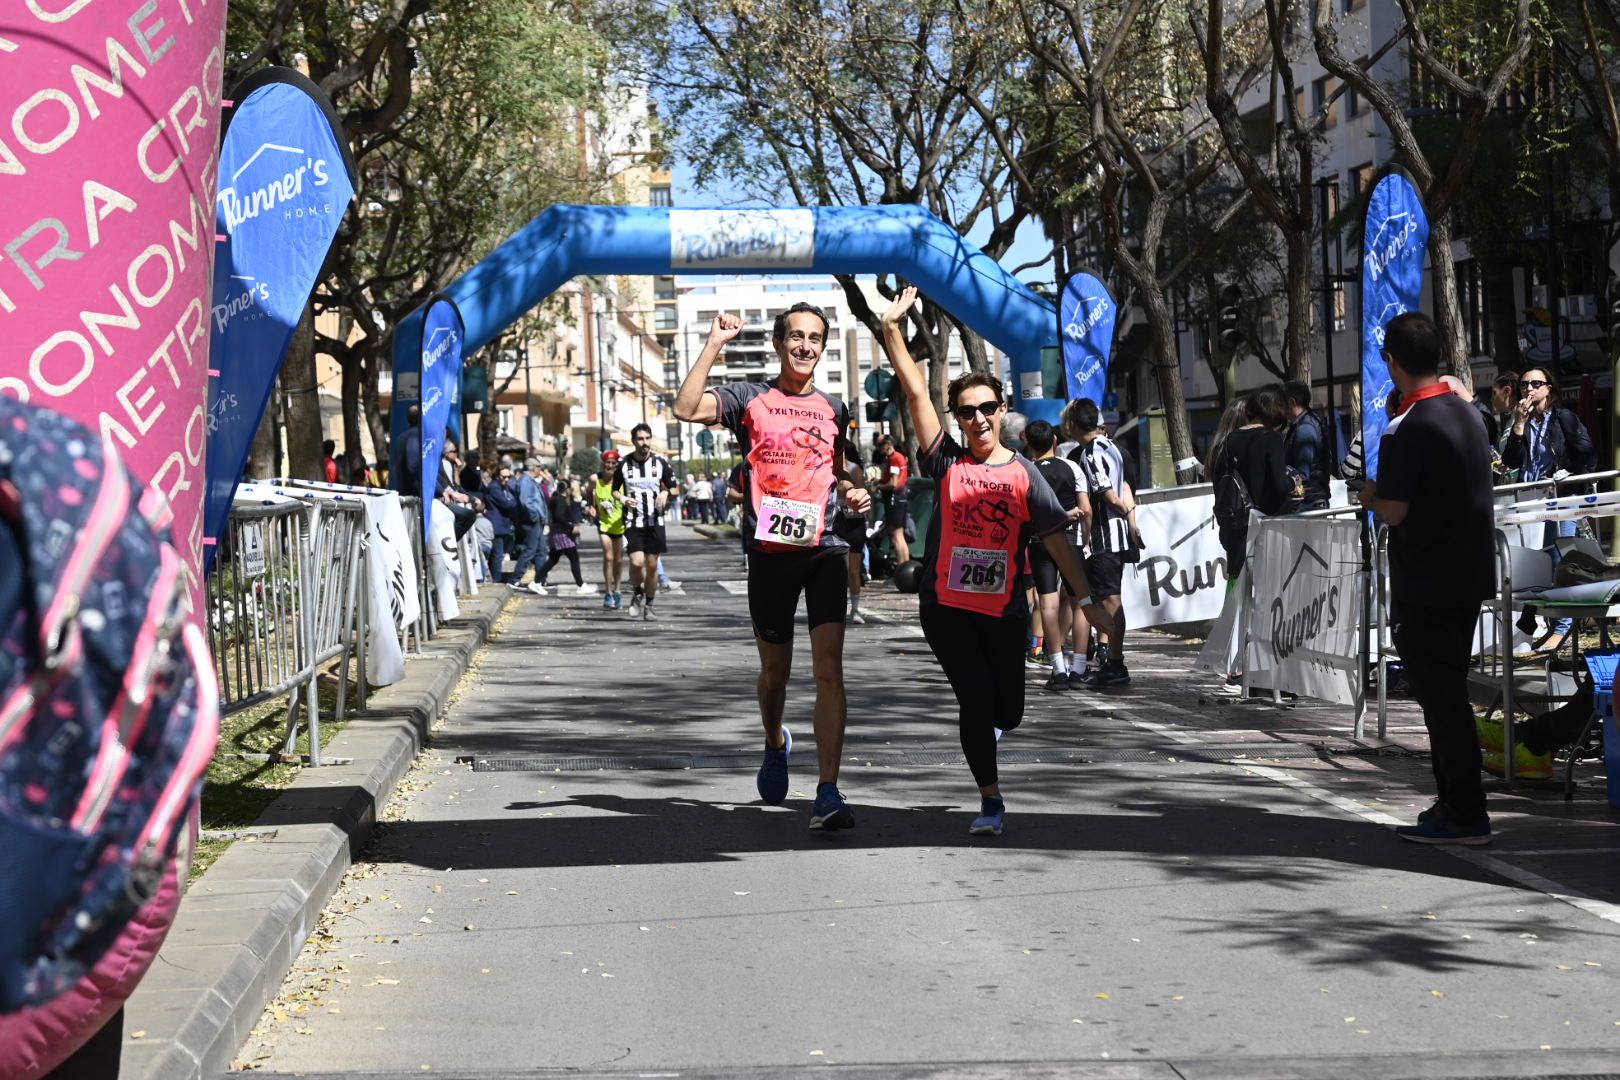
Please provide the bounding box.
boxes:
[883,288,1090,836]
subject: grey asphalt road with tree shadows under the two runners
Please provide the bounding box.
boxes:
[237,528,1620,1077]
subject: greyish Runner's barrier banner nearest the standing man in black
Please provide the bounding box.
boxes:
[1247,518,1361,704]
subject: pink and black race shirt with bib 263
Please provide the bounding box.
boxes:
[710,381,849,554]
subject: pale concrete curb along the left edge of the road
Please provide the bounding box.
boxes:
[120,588,512,1080]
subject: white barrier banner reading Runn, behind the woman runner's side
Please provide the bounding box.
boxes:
[1119,492,1226,628]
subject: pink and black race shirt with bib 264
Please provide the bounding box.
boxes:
[919,432,1069,617]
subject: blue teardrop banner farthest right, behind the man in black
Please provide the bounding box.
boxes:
[1361,170,1429,479]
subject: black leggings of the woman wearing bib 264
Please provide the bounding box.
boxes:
[920,604,1029,787]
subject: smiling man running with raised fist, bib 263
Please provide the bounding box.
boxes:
[676,303,870,829]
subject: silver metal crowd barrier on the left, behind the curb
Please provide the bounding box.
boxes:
[207,504,368,766]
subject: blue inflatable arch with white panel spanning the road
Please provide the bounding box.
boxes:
[392,206,1063,434]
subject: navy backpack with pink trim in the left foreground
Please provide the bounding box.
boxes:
[0,397,219,1012]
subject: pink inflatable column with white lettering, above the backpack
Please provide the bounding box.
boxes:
[0,0,225,602]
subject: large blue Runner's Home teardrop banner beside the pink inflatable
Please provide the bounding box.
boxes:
[203,68,355,559]
